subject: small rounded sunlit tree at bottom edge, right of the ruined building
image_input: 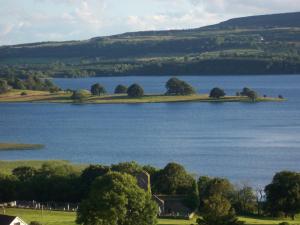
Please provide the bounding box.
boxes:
[197,195,244,225]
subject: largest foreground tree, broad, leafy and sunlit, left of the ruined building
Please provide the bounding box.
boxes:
[76,172,158,225]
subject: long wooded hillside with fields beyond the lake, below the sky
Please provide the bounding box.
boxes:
[0,12,300,77]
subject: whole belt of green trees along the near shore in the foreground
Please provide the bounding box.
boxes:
[0,162,300,225]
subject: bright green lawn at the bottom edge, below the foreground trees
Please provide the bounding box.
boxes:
[0,208,300,225]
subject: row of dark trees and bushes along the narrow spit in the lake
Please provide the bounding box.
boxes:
[0,76,283,101]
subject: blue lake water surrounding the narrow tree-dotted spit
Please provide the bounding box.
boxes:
[0,75,300,186]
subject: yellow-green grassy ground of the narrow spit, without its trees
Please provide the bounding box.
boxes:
[0,90,283,104]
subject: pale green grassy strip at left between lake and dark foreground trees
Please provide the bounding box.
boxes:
[0,160,86,174]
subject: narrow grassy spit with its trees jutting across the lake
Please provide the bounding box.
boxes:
[0,77,285,104]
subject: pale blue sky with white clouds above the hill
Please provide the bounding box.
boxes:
[0,0,300,45]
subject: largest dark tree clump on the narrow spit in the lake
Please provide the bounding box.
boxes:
[166,77,196,95]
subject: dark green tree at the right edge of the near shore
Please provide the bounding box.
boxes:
[265,171,300,219]
